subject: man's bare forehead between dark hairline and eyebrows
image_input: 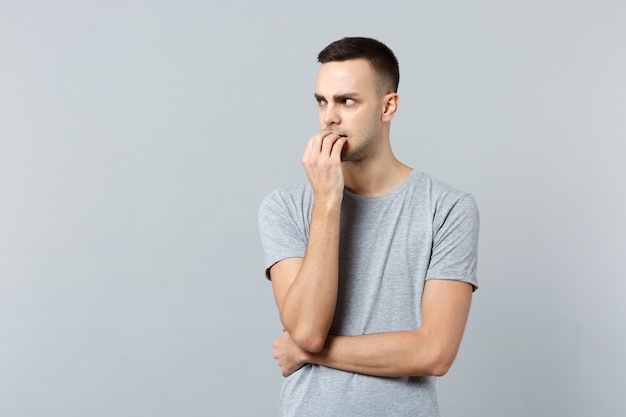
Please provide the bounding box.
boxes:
[315,59,376,95]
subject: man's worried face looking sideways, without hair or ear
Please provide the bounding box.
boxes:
[315,59,383,162]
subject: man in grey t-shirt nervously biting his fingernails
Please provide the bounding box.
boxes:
[259,38,479,417]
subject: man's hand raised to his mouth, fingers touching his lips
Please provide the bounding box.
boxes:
[302,131,346,201]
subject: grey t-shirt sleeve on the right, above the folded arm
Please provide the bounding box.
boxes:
[426,194,480,290]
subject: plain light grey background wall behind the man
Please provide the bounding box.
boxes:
[0,0,626,417]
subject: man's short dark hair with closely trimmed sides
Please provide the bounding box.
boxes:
[317,37,400,93]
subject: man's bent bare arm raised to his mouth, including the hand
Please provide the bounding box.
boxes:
[270,132,345,352]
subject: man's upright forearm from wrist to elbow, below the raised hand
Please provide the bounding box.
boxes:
[280,201,340,352]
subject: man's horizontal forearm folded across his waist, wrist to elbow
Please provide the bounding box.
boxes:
[305,330,457,377]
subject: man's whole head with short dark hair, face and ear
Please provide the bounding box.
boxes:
[315,38,399,162]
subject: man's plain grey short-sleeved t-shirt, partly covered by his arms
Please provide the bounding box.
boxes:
[259,171,479,417]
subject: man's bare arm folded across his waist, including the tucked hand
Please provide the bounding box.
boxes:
[274,279,472,377]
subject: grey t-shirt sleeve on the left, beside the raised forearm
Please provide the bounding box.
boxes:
[259,189,307,279]
